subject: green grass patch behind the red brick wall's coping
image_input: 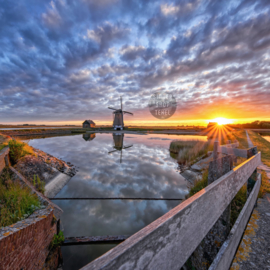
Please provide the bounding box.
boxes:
[0,168,41,227]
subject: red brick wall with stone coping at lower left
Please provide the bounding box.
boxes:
[0,167,62,270]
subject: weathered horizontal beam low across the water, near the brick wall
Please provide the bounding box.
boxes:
[62,235,130,246]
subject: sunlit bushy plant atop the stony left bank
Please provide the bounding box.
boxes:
[8,140,34,164]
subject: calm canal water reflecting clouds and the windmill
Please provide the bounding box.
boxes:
[29,134,206,270]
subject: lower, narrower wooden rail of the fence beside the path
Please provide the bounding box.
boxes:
[209,174,261,270]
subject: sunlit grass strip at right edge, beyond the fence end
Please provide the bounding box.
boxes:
[248,130,270,166]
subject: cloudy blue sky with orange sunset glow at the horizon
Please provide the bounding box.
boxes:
[0,0,270,125]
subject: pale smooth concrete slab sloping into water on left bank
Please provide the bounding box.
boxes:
[45,172,71,198]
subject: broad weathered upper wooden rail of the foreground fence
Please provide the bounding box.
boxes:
[82,153,261,270]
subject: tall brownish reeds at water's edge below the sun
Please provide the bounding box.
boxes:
[170,140,213,164]
